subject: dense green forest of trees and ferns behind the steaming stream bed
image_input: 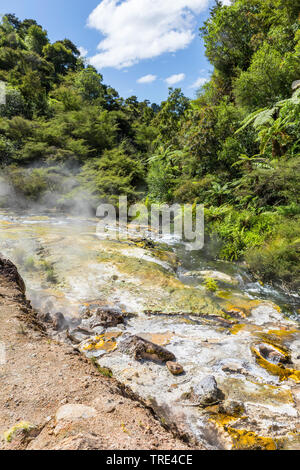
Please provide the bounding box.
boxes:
[0,0,300,290]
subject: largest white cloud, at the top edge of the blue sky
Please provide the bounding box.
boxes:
[88,0,209,69]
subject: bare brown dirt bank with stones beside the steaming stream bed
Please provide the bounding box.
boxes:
[0,258,199,450]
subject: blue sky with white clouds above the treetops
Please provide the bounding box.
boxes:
[0,0,228,103]
